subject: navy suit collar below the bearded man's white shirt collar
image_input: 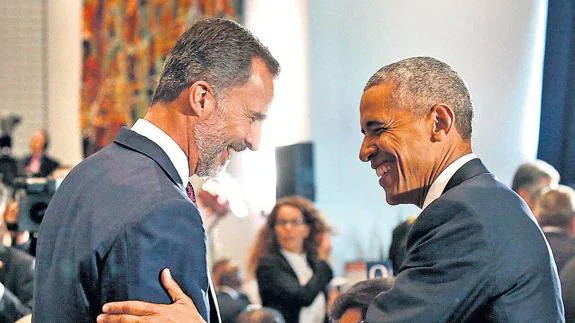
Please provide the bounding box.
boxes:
[114,127,183,185]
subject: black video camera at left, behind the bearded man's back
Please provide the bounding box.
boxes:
[14,177,57,232]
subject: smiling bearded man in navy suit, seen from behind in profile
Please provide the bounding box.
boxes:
[33,18,279,322]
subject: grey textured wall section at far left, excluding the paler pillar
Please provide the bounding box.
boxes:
[0,0,47,157]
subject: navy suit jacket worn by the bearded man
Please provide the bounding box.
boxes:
[33,128,217,322]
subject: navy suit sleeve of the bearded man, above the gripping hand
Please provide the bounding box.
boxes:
[101,200,209,321]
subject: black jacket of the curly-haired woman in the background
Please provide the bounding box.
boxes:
[256,251,333,323]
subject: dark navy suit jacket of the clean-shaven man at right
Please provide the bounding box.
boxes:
[367,159,564,323]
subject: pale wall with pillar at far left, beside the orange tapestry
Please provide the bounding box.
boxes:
[0,0,82,165]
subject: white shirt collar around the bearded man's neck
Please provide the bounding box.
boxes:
[132,119,190,189]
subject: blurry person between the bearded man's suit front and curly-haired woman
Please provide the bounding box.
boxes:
[212,259,251,323]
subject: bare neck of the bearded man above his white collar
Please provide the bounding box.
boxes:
[144,96,198,176]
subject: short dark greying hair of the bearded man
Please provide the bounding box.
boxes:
[152,18,280,104]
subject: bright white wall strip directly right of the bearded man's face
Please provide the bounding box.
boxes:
[230,0,310,213]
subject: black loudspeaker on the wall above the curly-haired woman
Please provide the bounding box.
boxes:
[276,142,315,201]
